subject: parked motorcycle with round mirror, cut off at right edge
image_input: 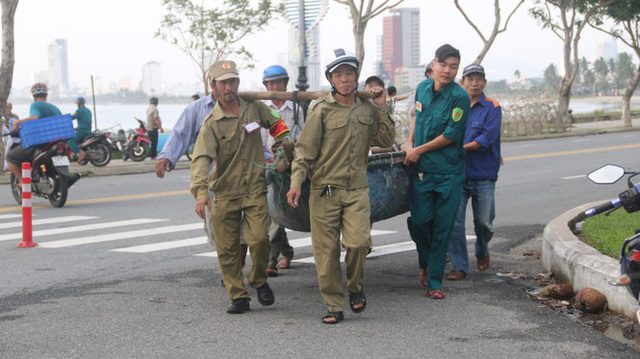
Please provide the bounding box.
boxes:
[569,165,640,322]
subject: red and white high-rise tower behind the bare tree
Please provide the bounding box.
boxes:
[382,8,420,83]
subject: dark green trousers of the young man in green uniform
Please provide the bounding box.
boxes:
[407,171,465,290]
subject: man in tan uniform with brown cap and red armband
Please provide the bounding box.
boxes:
[191,61,289,314]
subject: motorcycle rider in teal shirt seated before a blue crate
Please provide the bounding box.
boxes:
[7,82,62,181]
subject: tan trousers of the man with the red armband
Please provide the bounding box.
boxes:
[212,193,271,300]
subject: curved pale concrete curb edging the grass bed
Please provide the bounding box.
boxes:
[542,202,639,320]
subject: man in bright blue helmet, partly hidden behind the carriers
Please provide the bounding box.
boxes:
[262,65,304,277]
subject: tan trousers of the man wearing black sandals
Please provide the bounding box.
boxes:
[309,188,371,312]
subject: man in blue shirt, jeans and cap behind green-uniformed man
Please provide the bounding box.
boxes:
[447,64,502,280]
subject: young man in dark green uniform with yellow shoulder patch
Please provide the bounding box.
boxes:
[405,44,470,299]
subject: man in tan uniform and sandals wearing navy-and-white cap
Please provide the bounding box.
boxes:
[287,49,395,324]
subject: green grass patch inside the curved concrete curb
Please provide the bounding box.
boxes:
[582,208,640,259]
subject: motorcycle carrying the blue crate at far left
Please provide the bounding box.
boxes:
[11,140,80,208]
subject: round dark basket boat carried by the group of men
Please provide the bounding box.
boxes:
[267,152,409,232]
